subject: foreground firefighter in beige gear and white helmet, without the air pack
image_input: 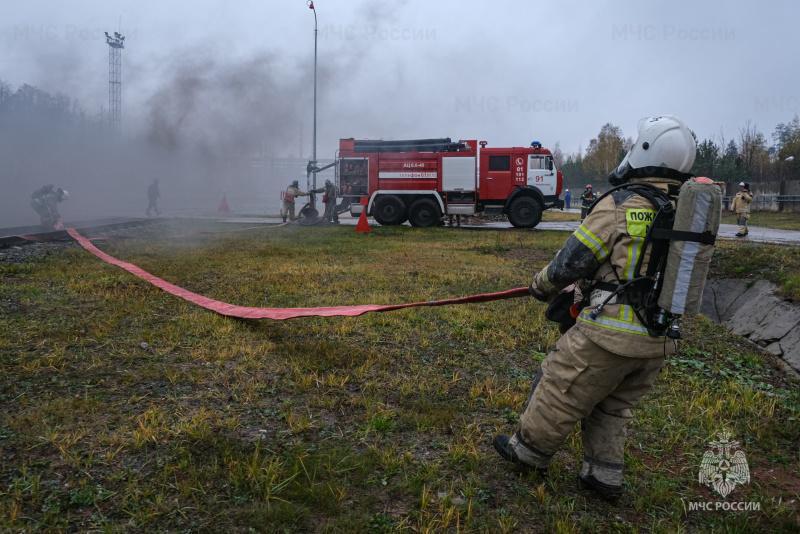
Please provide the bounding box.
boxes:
[493,116,696,499]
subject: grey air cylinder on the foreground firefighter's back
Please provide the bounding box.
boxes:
[658,178,722,315]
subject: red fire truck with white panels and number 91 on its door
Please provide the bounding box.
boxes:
[336,138,564,228]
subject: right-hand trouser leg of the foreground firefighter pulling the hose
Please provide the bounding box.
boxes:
[581,358,664,486]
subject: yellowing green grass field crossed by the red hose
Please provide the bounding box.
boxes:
[0,222,800,533]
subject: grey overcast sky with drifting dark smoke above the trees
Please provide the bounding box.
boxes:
[0,0,800,158]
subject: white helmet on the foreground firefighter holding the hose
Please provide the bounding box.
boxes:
[609,115,697,183]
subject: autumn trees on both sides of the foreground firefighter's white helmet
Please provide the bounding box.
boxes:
[553,114,800,191]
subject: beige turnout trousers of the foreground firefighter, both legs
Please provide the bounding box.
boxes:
[510,327,664,486]
